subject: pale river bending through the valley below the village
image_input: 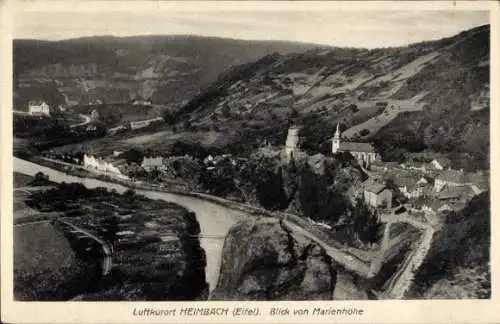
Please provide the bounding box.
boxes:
[13,157,366,300]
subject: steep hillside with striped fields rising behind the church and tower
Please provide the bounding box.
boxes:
[181,25,490,168]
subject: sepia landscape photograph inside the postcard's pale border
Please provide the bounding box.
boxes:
[4,1,492,315]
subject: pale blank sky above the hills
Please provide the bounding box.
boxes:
[13,6,489,48]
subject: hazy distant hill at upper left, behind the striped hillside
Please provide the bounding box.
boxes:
[13,36,326,109]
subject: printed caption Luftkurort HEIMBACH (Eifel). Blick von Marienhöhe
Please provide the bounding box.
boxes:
[133,307,364,317]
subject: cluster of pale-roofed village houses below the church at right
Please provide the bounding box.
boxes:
[350,158,489,220]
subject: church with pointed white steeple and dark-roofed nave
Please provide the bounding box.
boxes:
[332,123,380,168]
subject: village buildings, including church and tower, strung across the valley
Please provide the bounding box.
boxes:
[41,107,489,232]
